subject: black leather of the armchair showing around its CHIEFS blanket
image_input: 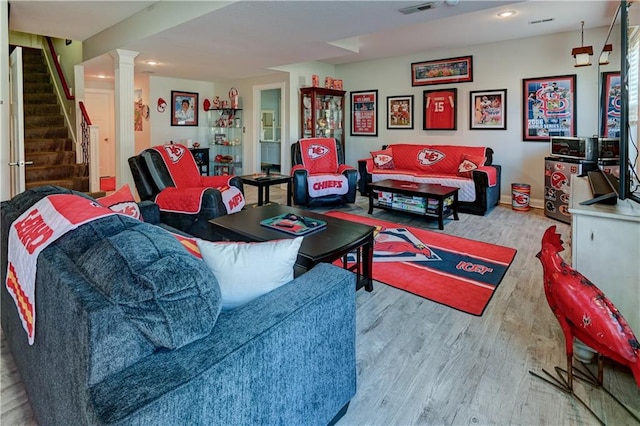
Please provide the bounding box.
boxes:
[291,138,358,207]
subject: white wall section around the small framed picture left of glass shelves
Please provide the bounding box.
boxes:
[149,76,214,147]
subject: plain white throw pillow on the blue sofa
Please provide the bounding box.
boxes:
[197,237,304,310]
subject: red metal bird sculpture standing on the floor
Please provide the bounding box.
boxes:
[536,225,640,392]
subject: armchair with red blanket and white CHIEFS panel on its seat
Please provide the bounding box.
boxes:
[291,138,358,207]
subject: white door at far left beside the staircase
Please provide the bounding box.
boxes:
[9,47,26,197]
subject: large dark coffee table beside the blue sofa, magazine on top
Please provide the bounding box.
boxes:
[209,204,375,291]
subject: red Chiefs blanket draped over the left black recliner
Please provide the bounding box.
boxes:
[153,144,245,214]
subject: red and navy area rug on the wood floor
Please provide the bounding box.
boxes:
[326,211,516,316]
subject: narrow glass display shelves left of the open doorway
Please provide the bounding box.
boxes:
[208,108,243,175]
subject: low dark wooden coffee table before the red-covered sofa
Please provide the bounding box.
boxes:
[368,179,459,230]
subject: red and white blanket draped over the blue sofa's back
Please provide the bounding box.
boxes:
[6,194,116,345]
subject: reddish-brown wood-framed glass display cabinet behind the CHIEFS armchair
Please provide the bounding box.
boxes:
[300,87,345,152]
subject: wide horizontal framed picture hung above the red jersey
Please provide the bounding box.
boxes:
[411,56,473,86]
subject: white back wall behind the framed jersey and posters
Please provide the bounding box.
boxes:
[336,27,620,207]
